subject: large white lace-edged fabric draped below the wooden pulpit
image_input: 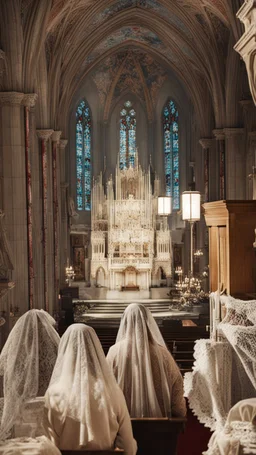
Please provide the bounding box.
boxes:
[184,292,256,430]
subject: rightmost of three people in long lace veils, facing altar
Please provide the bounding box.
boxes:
[107,303,186,417]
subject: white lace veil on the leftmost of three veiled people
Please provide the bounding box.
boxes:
[0,310,59,439]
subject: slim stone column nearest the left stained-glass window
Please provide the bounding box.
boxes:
[60,139,69,286]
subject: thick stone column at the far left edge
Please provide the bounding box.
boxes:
[0,92,29,313]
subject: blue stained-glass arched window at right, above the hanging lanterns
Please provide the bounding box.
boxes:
[163,100,180,210]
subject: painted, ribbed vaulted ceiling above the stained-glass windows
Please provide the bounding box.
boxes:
[15,0,242,134]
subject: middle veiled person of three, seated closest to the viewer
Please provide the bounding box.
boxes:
[44,324,137,455]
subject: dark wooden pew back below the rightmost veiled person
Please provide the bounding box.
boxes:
[131,417,187,455]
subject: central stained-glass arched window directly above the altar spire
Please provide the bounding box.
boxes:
[119,101,136,169]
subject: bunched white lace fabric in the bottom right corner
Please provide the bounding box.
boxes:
[203,398,256,455]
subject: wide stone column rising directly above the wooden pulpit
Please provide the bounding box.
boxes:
[224,128,246,199]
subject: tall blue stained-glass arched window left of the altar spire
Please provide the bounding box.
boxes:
[76,100,92,210]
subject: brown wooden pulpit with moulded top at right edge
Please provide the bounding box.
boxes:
[203,200,256,298]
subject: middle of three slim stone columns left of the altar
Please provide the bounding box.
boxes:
[51,131,61,308]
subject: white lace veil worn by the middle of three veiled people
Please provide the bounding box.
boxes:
[45,324,120,446]
